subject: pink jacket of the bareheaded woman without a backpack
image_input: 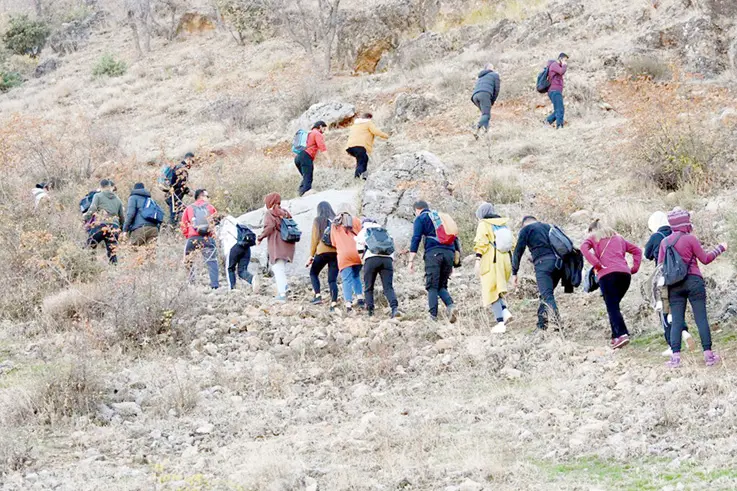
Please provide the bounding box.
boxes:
[581,235,642,279]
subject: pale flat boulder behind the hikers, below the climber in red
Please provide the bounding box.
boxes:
[234,188,359,276]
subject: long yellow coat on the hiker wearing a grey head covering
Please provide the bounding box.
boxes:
[473,217,512,307]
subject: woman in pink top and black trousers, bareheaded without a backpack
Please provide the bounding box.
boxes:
[581,219,642,349]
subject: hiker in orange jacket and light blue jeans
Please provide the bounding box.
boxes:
[330,205,366,312]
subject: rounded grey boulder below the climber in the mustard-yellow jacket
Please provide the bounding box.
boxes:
[361,152,455,249]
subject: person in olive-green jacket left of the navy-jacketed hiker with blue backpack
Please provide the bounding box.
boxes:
[82,179,125,264]
